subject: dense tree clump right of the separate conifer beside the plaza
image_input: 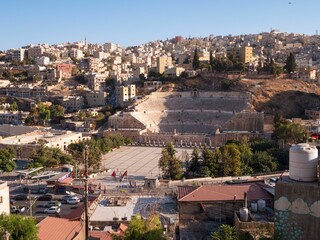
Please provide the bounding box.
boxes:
[186,139,278,177]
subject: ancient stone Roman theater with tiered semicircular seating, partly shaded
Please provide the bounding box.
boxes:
[108,89,264,146]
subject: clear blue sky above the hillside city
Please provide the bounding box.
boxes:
[0,0,320,50]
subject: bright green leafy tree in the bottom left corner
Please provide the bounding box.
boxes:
[0,214,38,240]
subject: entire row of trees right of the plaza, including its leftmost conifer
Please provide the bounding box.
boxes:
[159,138,288,179]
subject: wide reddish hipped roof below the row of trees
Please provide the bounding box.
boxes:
[179,183,273,202]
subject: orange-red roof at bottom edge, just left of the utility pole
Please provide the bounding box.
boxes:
[37,217,82,240]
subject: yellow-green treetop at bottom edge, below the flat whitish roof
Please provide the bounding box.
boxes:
[112,214,166,240]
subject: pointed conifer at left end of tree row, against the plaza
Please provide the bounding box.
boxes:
[159,142,182,180]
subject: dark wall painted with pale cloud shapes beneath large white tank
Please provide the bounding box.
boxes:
[275,180,320,240]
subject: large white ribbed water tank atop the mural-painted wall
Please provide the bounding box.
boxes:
[289,143,318,182]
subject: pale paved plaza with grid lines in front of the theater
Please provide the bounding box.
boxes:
[102,146,193,179]
